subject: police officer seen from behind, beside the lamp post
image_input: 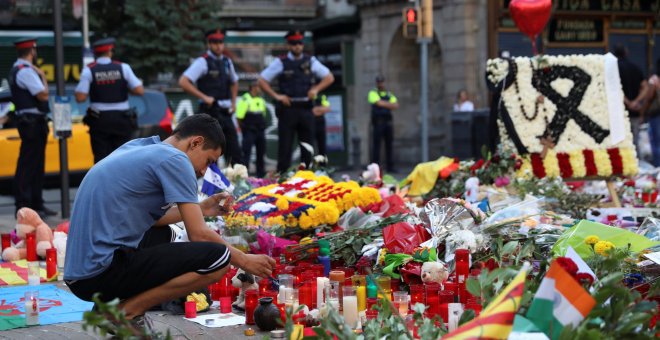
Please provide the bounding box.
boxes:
[75,38,144,163]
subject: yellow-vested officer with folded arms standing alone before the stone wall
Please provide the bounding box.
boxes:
[368,76,399,172]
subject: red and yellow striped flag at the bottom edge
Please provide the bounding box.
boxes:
[443,263,529,340]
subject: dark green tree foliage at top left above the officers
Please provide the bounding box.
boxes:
[90,0,220,82]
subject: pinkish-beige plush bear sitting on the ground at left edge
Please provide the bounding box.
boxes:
[2,208,53,261]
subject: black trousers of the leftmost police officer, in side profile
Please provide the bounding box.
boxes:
[13,113,48,210]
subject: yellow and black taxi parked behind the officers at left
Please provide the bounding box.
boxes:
[0,87,174,179]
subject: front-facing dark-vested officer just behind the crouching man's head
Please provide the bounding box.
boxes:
[179,29,243,165]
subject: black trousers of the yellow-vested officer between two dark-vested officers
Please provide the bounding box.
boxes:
[241,114,266,177]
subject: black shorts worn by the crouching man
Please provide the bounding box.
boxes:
[66,227,231,301]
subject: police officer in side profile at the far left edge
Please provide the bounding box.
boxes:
[8,39,57,217]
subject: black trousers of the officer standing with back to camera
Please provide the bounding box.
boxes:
[85,111,136,163]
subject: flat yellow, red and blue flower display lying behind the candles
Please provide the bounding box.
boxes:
[227,171,381,229]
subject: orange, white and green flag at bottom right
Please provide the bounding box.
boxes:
[527,261,596,339]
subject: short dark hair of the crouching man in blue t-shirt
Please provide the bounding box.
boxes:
[172,113,227,153]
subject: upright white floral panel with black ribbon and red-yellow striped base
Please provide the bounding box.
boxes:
[486,54,638,178]
